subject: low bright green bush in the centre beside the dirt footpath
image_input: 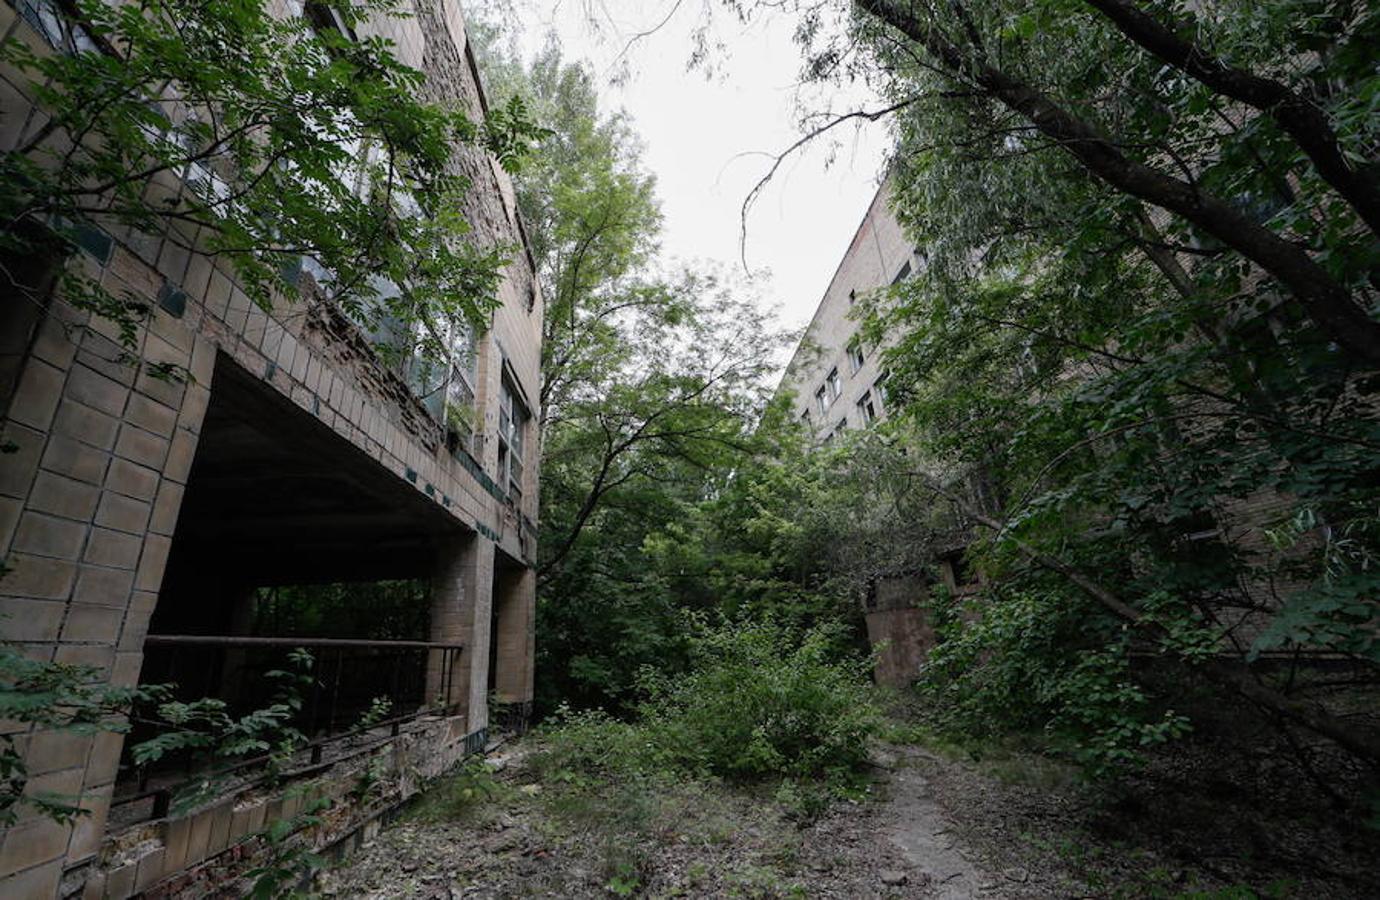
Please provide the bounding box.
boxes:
[534,623,882,790]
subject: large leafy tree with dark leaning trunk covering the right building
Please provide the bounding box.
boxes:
[828,3,1380,766]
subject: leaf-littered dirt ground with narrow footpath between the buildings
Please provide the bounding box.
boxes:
[320,734,1380,900]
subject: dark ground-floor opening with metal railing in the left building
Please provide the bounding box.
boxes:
[115,356,462,806]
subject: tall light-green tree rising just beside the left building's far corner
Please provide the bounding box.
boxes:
[471,26,781,708]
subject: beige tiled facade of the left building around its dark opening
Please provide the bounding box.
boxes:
[0,0,542,897]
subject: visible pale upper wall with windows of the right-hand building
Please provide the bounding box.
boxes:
[778,176,923,442]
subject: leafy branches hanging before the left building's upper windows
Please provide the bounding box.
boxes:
[0,0,540,358]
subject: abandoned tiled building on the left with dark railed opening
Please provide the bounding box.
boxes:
[0,0,542,899]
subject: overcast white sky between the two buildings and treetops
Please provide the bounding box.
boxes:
[491,0,889,329]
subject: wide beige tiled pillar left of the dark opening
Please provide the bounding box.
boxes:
[0,298,215,897]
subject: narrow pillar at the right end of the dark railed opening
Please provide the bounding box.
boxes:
[426,534,494,733]
